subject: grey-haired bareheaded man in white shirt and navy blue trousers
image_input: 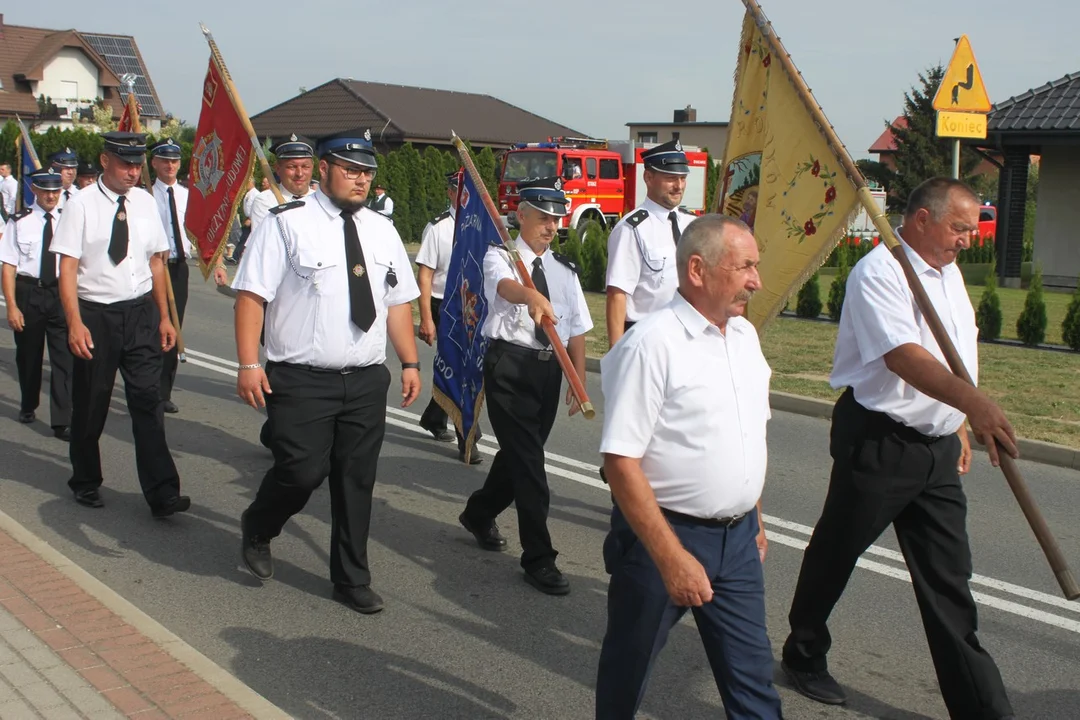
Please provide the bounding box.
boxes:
[596,215,781,720]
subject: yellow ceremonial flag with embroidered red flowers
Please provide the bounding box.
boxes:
[718,12,859,328]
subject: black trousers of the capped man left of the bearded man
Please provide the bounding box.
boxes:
[68,295,180,506]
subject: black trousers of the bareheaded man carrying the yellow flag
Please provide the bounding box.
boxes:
[783,389,1012,720]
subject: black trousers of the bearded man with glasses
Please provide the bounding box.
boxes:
[246,363,390,587]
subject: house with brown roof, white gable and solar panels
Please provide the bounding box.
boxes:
[0,13,164,132]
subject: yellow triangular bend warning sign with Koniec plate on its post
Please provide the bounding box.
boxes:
[933,35,990,179]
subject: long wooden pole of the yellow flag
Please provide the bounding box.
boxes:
[743,0,1080,600]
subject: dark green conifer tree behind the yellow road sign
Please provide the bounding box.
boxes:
[889,65,982,213]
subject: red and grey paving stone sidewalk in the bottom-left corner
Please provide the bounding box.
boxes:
[0,513,287,720]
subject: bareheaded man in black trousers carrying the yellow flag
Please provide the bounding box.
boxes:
[783,178,1016,720]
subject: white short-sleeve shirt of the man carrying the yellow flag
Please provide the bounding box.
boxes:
[831,233,978,437]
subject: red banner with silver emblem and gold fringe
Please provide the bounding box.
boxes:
[184,57,255,277]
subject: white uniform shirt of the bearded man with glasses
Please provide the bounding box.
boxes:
[232,191,420,369]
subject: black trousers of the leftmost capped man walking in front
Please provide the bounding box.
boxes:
[14,277,72,427]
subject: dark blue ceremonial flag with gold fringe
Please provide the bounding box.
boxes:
[432,173,502,462]
